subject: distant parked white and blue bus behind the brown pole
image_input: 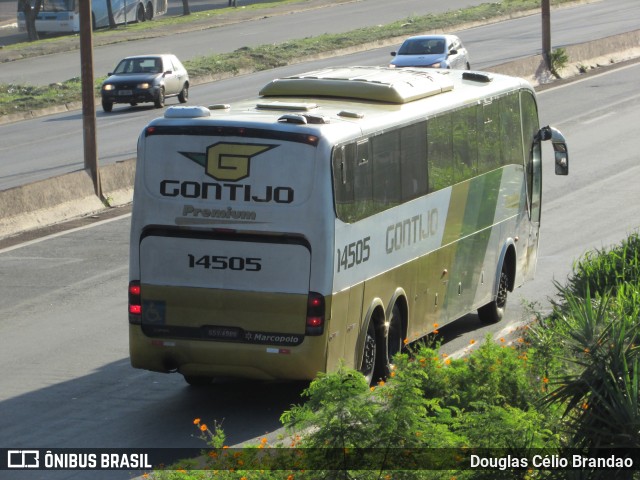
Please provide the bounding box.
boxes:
[18,0,167,33]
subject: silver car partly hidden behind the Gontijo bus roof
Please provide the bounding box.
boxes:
[389,35,471,70]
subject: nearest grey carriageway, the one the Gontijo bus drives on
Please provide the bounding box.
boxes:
[0,64,640,480]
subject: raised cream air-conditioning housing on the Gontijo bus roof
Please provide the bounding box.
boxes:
[260,67,453,103]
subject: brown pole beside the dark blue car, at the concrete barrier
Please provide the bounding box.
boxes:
[78,0,102,199]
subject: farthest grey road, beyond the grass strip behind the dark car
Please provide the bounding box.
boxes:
[0,0,484,85]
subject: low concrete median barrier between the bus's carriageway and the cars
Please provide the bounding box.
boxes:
[0,30,640,239]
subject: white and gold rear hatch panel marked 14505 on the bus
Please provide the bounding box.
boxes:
[140,233,311,341]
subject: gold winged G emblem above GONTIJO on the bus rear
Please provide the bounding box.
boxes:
[180,142,276,182]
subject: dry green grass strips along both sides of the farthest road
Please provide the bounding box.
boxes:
[0,0,573,115]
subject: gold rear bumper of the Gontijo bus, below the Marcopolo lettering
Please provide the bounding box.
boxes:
[129,325,326,380]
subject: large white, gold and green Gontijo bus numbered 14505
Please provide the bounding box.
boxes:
[128,67,569,385]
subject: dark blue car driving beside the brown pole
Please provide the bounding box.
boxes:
[100,54,189,112]
